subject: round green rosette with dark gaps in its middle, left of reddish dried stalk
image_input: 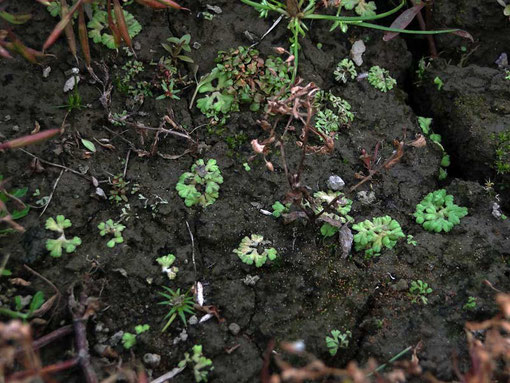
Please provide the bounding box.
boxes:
[175,159,223,207]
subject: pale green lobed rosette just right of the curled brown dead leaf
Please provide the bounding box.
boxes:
[352,215,405,258]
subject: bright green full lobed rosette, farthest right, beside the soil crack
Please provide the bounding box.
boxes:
[414,189,468,233]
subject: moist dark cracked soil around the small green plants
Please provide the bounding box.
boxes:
[0,0,510,383]
